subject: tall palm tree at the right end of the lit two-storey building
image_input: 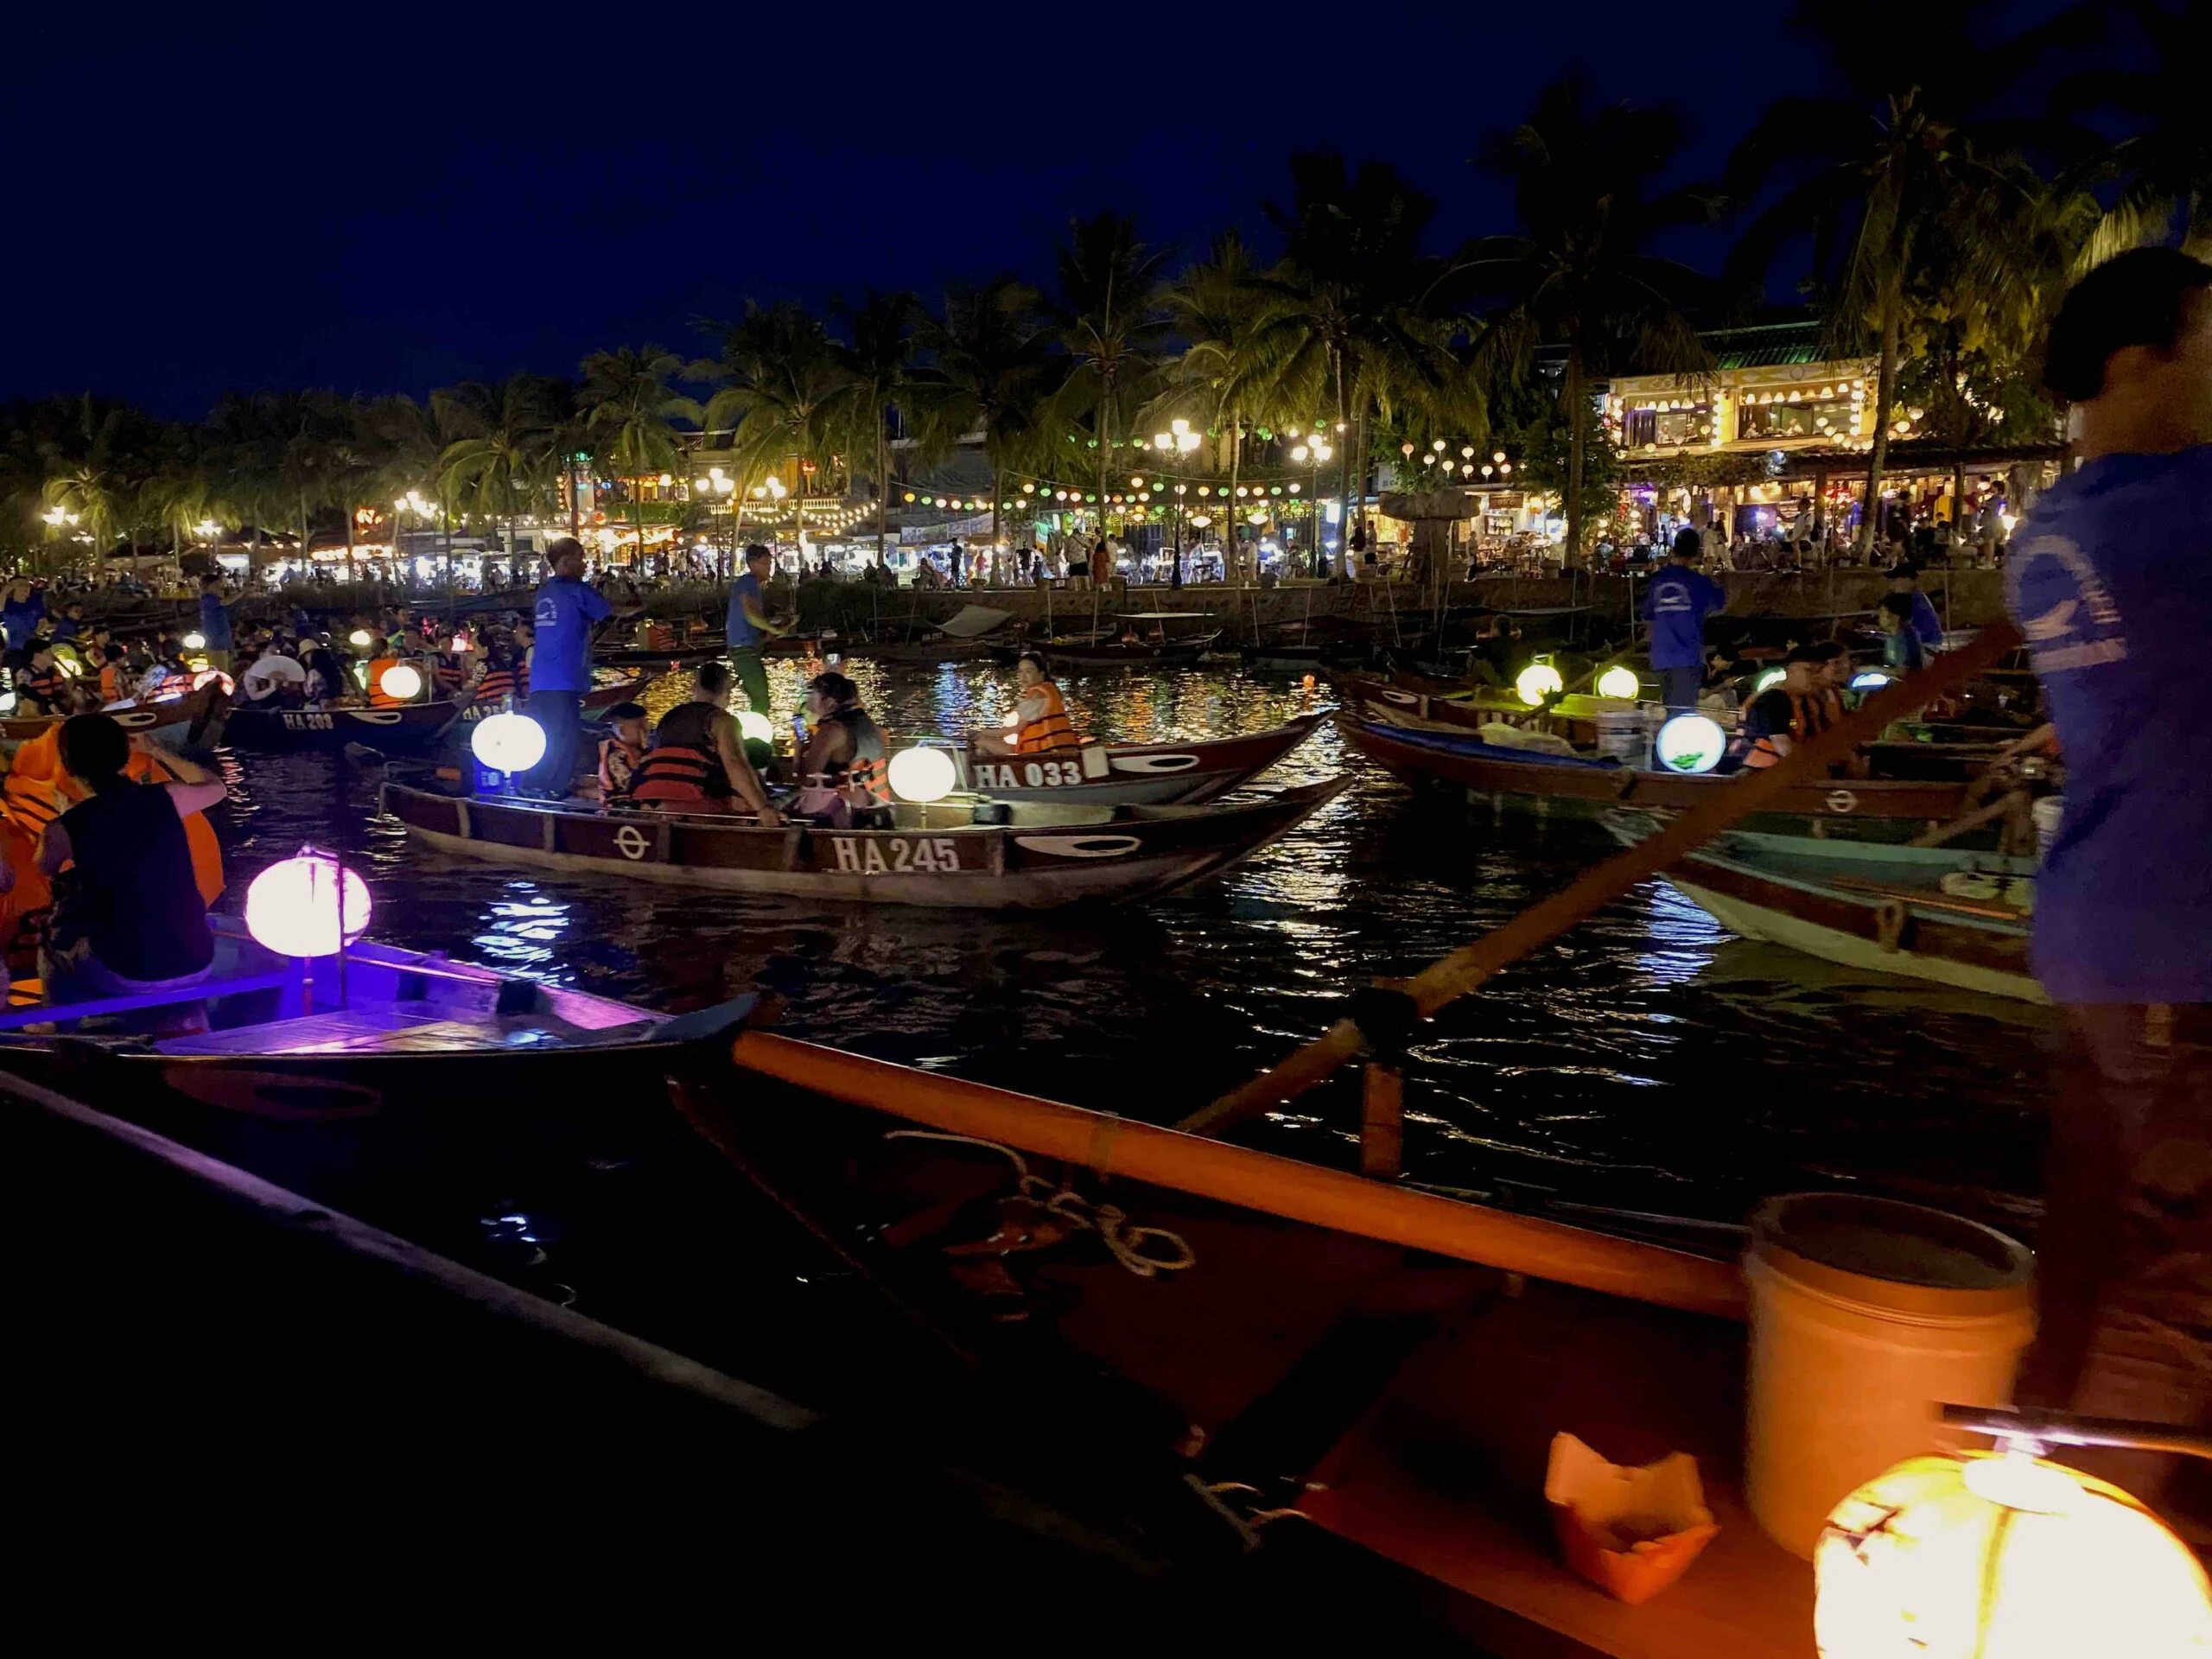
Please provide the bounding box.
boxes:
[1730,0,2094,546]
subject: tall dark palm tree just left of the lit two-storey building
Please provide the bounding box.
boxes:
[1458,75,1717,557]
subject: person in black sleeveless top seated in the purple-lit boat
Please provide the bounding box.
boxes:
[38,715,224,1031]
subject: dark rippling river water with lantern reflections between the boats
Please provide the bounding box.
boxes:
[207,664,2050,1362]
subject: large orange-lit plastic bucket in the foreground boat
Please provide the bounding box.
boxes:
[1743,1192,2035,1560]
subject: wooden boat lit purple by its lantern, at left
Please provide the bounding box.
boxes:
[0,916,752,1176]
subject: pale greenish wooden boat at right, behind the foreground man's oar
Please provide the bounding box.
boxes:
[1606,814,2050,1002]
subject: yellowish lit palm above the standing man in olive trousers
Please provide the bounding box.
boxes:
[690,301,849,562]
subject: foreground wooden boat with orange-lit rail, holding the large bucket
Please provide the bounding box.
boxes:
[683,1031,1812,1659]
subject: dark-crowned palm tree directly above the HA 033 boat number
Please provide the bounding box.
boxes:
[916,276,1057,542]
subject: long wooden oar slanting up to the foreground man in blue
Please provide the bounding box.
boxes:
[1177,621,2019,1135]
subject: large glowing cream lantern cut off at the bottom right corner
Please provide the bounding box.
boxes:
[1812,1451,2212,1659]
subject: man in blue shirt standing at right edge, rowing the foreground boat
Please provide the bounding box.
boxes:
[2006,248,2212,1504]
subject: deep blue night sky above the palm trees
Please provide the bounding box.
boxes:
[17,0,2079,418]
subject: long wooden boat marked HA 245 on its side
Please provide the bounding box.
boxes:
[378,779,1344,909]
